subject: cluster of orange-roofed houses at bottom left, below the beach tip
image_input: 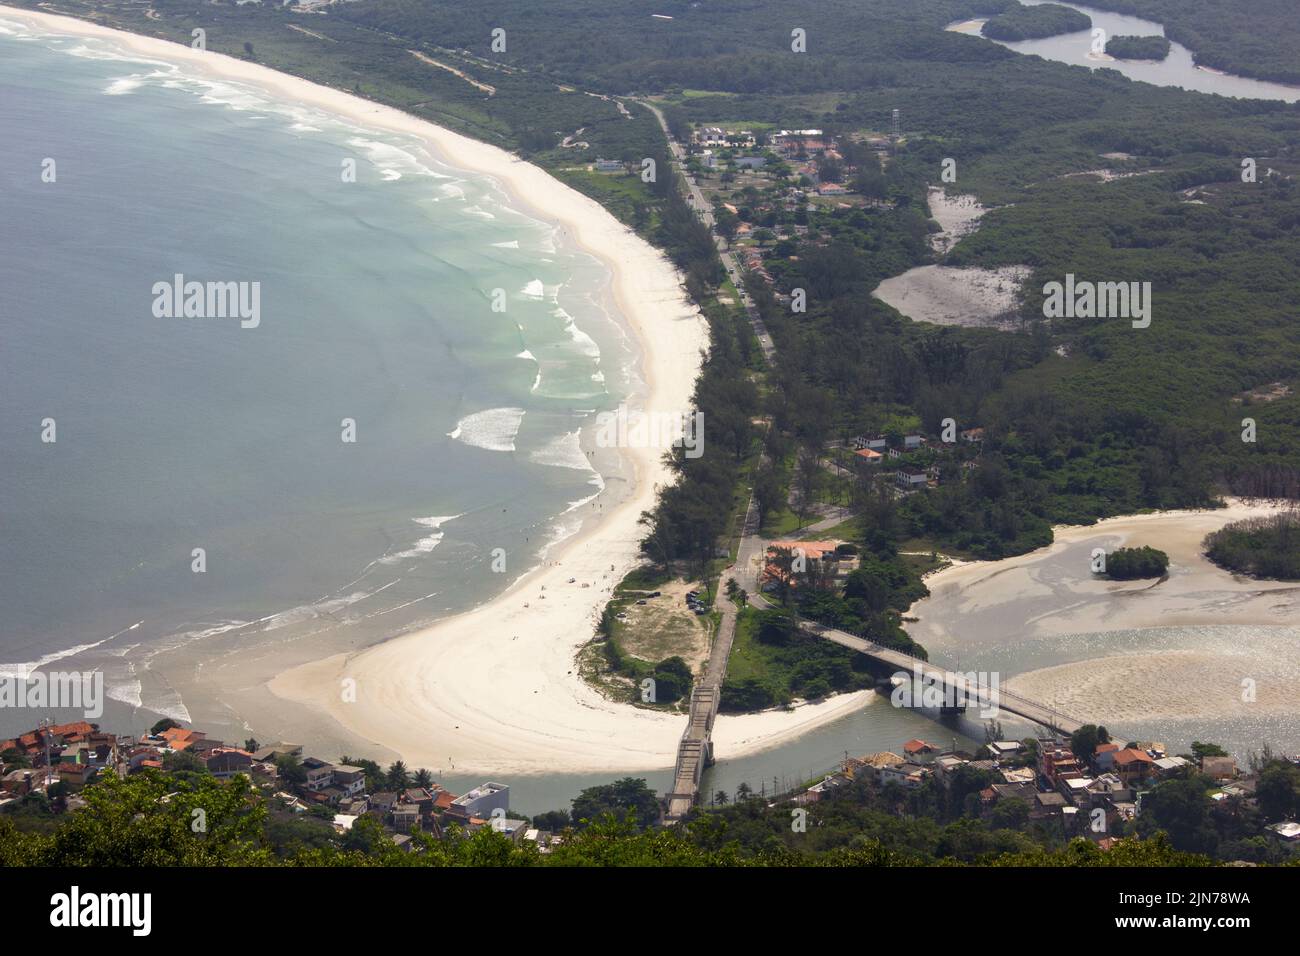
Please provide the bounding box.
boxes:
[0,721,559,852]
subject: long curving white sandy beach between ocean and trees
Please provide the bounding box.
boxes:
[0,7,883,775]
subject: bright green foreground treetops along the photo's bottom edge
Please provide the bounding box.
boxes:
[0,769,1258,866]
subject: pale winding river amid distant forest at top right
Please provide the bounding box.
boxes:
[945,0,1300,103]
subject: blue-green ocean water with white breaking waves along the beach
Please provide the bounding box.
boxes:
[0,18,640,740]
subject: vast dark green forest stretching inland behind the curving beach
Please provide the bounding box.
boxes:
[25,0,1300,570]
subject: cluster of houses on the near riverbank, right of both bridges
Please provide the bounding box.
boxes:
[793,736,1284,849]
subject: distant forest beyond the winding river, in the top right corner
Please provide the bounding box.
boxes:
[1088,0,1300,85]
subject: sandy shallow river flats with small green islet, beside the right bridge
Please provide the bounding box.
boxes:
[907,503,1300,756]
